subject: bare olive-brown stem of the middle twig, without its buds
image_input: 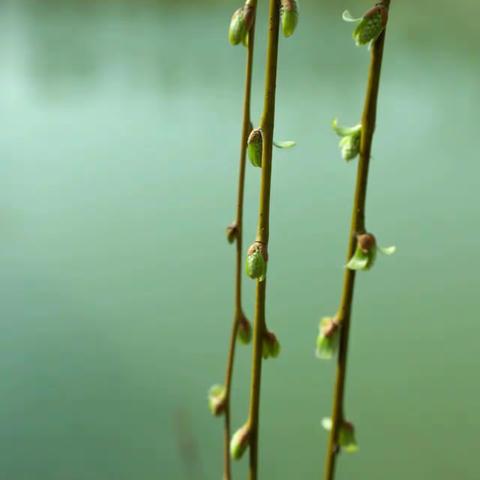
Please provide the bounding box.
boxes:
[249,0,280,480]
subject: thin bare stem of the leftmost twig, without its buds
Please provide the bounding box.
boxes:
[223,1,256,480]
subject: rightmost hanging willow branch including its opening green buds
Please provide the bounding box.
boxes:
[317,0,394,480]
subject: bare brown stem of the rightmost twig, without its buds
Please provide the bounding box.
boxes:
[324,0,390,480]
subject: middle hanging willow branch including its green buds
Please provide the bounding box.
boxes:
[230,0,298,480]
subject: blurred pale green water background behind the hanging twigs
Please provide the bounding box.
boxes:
[0,0,480,480]
